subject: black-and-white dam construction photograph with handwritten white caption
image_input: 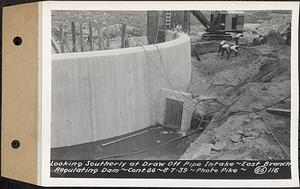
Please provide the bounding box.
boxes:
[41,0,295,186]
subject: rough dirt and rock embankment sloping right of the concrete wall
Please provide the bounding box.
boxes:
[181,45,290,160]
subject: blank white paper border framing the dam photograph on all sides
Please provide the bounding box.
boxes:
[38,1,299,187]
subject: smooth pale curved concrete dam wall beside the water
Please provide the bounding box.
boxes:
[51,34,191,147]
